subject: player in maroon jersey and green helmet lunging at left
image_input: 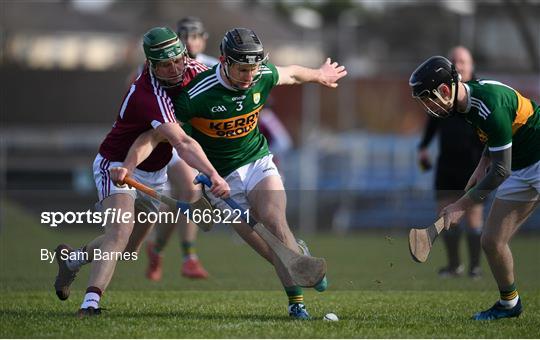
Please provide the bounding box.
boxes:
[54,27,229,317]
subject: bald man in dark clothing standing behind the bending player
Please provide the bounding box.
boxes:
[418,46,484,278]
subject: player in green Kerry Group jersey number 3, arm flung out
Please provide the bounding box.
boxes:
[117,28,347,319]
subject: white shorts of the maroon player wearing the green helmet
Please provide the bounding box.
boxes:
[93,154,167,212]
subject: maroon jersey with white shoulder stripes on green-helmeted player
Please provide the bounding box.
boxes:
[99,59,208,172]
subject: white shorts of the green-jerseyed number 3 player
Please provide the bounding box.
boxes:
[205,155,281,210]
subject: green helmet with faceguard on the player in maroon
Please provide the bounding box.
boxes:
[143,27,186,65]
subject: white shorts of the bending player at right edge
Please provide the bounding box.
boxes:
[495,161,540,202]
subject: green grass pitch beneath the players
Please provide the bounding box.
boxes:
[0,205,540,338]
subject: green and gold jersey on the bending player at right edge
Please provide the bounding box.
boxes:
[465,80,540,170]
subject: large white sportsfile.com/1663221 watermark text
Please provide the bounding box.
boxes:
[41,208,250,227]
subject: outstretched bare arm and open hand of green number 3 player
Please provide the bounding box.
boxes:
[276,58,347,88]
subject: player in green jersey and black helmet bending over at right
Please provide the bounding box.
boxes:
[409,56,540,320]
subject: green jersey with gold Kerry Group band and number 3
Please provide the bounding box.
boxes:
[174,64,279,177]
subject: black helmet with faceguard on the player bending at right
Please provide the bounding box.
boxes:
[409,56,460,118]
